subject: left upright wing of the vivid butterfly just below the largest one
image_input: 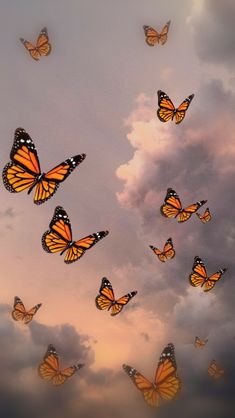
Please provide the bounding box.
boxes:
[42,206,72,254]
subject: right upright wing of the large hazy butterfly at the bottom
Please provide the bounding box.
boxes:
[155,343,181,400]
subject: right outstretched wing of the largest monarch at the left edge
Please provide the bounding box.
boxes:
[34,154,86,205]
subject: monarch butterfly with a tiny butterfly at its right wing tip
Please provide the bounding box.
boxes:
[160,188,207,222]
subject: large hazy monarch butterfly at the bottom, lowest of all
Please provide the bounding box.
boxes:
[123,343,181,406]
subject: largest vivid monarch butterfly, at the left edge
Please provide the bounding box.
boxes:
[2,128,86,205]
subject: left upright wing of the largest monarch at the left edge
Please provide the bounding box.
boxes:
[2,128,41,193]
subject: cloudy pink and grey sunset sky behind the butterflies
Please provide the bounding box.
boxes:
[0,0,235,418]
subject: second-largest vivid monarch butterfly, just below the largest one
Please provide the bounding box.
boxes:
[42,206,109,264]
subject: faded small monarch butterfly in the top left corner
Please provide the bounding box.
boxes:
[20,28,51,61]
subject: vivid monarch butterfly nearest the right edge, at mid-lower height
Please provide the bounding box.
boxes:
[189,256,227,292]
